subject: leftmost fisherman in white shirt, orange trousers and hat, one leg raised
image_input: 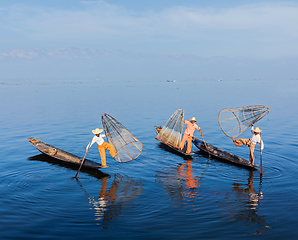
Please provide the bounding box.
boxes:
[86,128,116,167]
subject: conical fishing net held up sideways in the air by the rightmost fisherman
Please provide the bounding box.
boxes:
[218,105,269,138]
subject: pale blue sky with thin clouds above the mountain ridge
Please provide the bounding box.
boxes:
[0,0,298,59]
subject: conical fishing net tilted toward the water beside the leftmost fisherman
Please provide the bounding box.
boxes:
[101,113,143,163]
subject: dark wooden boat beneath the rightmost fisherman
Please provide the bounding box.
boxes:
[192,137,254,168]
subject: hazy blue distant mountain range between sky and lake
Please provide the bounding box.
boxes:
[0,47,298,80]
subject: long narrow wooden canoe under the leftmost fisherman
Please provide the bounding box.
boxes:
[26,137,102,169]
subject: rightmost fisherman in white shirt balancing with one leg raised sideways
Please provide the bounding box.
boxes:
[232,124,264,167]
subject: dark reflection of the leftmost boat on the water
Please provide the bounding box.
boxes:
[28,154,110,179]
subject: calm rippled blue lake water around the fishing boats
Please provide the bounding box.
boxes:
[0,79,298,240]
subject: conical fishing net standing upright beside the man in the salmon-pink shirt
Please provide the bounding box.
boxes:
[156,108,184,148]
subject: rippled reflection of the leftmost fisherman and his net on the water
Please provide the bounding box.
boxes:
[77,174,143,222]
